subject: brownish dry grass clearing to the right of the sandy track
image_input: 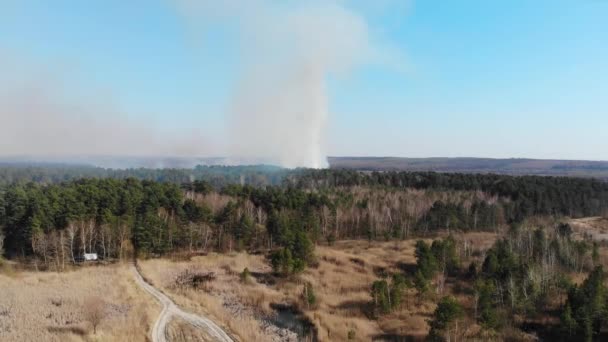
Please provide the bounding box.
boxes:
[140,233,496,341]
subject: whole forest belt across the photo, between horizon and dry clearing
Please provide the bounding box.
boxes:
[0,166,608,264]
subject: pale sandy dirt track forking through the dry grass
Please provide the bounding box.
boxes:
[133,266,234,342]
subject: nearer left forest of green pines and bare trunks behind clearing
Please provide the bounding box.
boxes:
[0,178,327,272]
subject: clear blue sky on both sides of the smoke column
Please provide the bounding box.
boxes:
[0,0,608,160]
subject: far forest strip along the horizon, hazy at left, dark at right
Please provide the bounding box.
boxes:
[0,165,608,221]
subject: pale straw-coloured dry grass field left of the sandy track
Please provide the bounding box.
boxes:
[0,265,160,342]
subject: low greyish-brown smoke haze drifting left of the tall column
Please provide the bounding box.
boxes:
[0,55,208,161]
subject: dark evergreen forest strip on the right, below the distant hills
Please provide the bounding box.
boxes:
[297,170,608,221]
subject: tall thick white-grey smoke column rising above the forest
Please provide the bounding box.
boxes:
[180,0,380,168]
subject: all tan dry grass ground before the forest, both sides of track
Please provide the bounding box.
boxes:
[0,226,596,342]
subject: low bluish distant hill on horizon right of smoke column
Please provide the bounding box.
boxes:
[328,157,608,179]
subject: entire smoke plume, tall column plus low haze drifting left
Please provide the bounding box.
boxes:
[0,0,404,168]
